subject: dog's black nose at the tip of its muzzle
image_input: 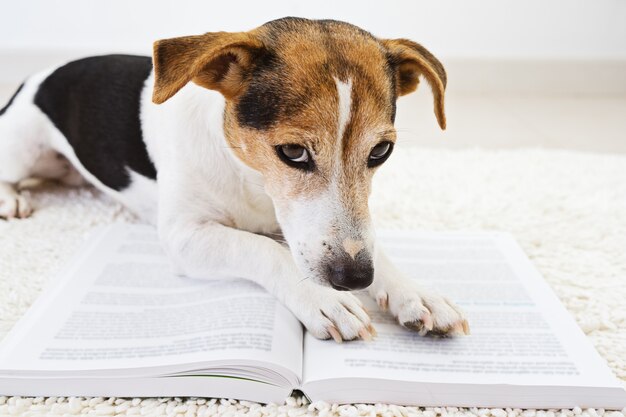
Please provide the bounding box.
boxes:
[327,251,374,291]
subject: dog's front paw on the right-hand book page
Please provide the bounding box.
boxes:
[373,283,469,337]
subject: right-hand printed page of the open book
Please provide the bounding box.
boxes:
[304,233,618,386]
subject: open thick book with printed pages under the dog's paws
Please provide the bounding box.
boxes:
[0,224,626,408]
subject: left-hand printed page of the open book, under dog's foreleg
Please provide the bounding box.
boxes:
[0,224,302,379]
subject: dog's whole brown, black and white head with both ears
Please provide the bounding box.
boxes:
[153,18,446,290]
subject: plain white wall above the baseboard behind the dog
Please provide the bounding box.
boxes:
[0,0,626,60]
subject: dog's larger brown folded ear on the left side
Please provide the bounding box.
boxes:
[152,32,263,104]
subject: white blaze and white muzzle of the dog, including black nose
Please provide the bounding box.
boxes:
[268,77,374,289]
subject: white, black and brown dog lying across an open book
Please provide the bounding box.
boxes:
[0,18,469,342]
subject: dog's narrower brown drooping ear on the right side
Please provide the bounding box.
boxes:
[381,39,447,129]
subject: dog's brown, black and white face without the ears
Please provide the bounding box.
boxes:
[217,24,396,290]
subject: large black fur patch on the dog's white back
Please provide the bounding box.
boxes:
[35,55,156,191]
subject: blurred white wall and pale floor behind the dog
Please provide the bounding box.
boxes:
[0,0,626,153]
